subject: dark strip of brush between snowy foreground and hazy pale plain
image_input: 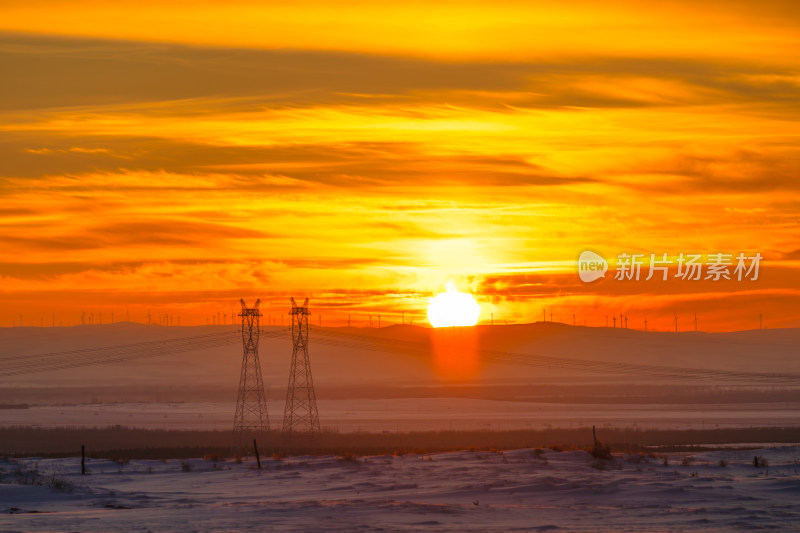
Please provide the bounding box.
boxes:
[0,426,800,459]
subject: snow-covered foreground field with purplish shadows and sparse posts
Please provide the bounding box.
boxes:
[0,447,800,532]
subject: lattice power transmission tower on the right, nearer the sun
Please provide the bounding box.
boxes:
[283,298,320,437]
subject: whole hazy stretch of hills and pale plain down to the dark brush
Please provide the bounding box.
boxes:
[0,323,800,432]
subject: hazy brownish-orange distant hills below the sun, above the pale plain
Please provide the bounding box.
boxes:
[0,322,800,399]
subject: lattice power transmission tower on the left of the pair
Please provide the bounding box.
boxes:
[233,300,269,450]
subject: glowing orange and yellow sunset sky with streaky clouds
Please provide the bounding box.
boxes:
[0,0,800,331]
